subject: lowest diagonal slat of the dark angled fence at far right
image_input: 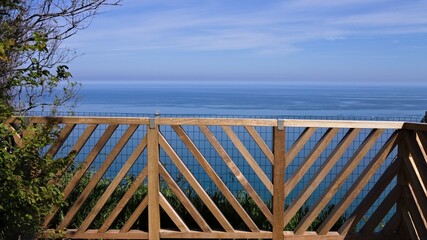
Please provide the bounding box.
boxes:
[402,186,427,236]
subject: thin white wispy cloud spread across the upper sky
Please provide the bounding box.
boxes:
[63,0,427,53]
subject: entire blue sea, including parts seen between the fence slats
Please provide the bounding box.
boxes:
[53,81,427,225]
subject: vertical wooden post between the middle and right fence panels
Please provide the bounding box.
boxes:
[273,120,285,240]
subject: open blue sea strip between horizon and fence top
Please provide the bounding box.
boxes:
[76,81,427,118]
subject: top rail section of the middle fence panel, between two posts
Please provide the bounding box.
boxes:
[157,118,277,127]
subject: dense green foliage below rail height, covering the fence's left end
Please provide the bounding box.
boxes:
[0,123,74,239]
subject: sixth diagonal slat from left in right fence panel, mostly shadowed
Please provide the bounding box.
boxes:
[338,160,402,235]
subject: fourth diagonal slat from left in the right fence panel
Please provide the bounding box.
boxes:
[295,129,384,234]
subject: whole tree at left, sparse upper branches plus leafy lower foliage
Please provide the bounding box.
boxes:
[0,0,119,239]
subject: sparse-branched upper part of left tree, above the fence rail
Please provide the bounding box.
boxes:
[0,0,120,113]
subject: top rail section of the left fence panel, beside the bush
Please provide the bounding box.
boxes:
[29,116,148,125]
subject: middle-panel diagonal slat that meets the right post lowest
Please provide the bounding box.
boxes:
[199,126,273,223]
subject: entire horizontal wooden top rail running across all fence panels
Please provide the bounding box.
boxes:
[6,116,427,131]
